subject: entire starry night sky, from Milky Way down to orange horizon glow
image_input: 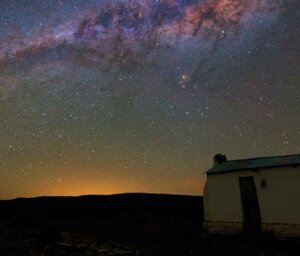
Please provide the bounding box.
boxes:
[0,0,300,199]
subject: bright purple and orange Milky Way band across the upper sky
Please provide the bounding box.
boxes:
[0,0,282,68]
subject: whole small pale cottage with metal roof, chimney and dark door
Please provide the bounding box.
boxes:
[203,154,300,237]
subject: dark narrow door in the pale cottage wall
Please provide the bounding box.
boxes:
[239,176,261,232]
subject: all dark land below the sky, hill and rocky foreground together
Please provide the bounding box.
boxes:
[0,194,300,256]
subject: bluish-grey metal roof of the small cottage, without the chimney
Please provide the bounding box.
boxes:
[206,154,300,175]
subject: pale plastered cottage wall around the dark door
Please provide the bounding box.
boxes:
[203,166,300,234]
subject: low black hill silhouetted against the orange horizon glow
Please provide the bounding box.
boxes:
[0,193,203,222]
